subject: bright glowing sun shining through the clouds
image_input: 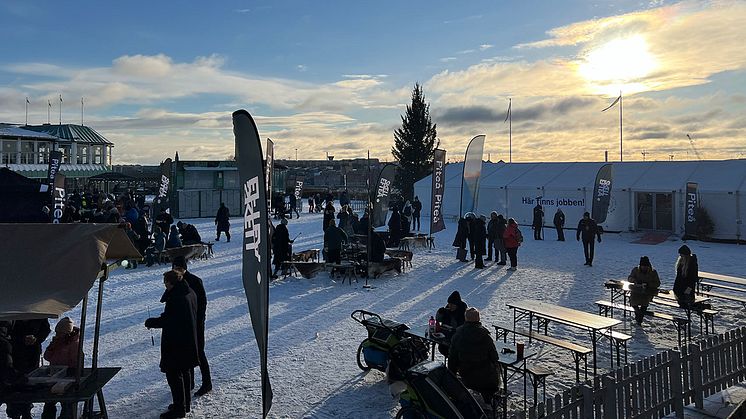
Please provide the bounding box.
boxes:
[578,35,658,95]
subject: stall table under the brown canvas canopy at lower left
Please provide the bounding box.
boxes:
[0,367,121,419]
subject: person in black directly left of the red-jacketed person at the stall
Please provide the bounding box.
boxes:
[6,319,51,419]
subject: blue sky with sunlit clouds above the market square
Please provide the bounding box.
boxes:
[0,1,746,163]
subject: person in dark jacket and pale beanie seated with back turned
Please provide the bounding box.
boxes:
[448,308,500,404]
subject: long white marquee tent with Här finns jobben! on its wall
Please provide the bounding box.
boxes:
[415,159,746,240]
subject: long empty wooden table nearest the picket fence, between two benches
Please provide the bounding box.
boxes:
[508,300,621,374]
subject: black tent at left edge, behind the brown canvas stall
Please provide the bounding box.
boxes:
[0,167,51,223]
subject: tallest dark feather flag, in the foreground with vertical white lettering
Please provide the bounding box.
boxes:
[233,109,272,418]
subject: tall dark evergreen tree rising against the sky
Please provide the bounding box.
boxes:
[391,83,440,200]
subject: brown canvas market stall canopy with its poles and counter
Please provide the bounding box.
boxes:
[0,223,142,417]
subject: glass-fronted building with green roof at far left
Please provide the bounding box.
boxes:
[0,123,114,189]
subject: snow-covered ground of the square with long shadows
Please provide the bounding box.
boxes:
[0,214,746,419]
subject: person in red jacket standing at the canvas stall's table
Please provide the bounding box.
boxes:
[41,317,80,419]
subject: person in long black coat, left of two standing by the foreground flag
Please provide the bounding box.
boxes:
[145,270,199,419]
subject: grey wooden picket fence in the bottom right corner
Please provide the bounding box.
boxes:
[515,327,746,419]
